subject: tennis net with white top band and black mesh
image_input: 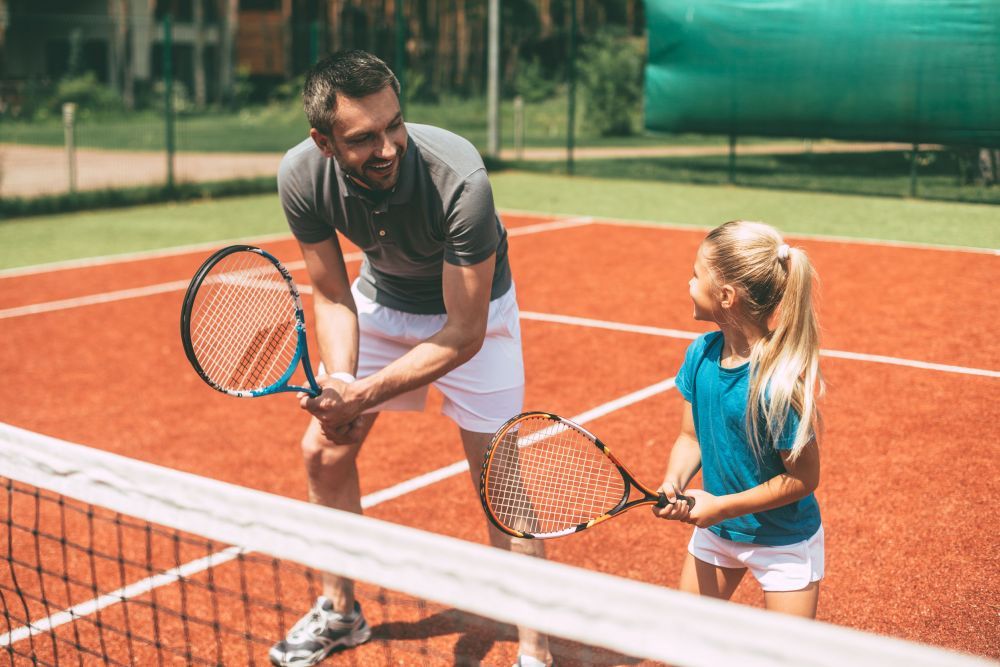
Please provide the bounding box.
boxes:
[0,424,988,667]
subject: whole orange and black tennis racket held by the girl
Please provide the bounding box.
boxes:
[479,412,694,539]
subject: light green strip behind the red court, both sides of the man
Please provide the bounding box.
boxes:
[0,171,1000,268]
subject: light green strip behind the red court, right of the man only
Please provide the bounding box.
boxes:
[492,171,1000,248]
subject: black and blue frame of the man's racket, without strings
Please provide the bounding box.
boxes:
[181,244,322,398]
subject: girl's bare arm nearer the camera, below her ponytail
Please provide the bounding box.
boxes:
[687,440,819,528]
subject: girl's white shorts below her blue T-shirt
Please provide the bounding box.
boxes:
[688,526,824,591]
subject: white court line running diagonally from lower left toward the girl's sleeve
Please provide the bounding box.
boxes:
[0,378,674,646]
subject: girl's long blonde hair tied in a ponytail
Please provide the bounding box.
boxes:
[704,220,823,459]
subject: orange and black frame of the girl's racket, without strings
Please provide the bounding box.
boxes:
[479,411,672,539]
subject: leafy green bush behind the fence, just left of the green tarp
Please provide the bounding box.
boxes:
[577,30,643,137]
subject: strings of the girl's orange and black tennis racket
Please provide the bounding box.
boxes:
[487,417,627,534]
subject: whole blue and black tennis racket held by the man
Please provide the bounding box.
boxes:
[181,245,320,398]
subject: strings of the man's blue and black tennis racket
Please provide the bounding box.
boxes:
[191,252,298,390]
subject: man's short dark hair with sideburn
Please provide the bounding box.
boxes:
[302,49,399,136]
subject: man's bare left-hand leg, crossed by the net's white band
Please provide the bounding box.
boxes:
[302,413,378,614]
